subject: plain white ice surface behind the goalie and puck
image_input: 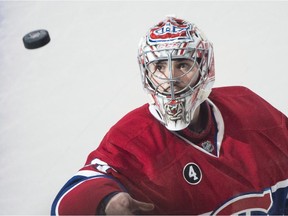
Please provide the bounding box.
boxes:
[0,1,288,215]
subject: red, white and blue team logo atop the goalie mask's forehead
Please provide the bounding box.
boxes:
[148,22,192,43]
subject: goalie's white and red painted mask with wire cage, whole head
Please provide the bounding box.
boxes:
[138,17,215,131]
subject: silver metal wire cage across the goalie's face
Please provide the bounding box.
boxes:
[140,48,208,100]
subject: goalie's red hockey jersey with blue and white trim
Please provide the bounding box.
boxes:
[51,87,288,215]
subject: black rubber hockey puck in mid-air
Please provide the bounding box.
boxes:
[23,29,50,49]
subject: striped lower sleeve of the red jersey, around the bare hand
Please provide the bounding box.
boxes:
[51,158,125,215]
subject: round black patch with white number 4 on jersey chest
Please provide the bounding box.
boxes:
[183,163,202,185]
